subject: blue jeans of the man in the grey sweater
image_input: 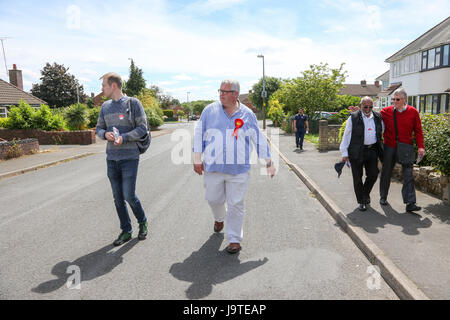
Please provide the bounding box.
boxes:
[106,159,147,233]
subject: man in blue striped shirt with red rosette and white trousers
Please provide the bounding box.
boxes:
[194,80,276,254]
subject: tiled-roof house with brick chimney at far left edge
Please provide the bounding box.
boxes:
[0,65,47,118]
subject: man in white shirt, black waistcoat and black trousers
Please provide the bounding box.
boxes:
[340,97,384,211]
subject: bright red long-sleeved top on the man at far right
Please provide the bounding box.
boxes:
[380,105,425,149]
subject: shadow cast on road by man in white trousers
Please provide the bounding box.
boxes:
[170,233,269,299]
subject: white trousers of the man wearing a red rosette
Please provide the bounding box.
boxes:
[203,171,250,243]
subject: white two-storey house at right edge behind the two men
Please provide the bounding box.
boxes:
[383,17,450,114]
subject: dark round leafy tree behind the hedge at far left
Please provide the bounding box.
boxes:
[31,62,87,108]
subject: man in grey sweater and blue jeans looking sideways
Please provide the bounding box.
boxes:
[96,72,148,246]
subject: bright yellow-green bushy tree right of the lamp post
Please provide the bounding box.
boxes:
[273,63,346,118]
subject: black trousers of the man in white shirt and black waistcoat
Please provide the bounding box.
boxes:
[350,145,379,204]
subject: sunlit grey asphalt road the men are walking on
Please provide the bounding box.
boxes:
[0,123,397,300]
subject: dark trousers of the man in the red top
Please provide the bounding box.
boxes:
[380,145,416,204]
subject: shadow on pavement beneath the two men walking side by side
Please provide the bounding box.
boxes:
[347,205,433,236]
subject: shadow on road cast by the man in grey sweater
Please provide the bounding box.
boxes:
[31,238,139,294]
